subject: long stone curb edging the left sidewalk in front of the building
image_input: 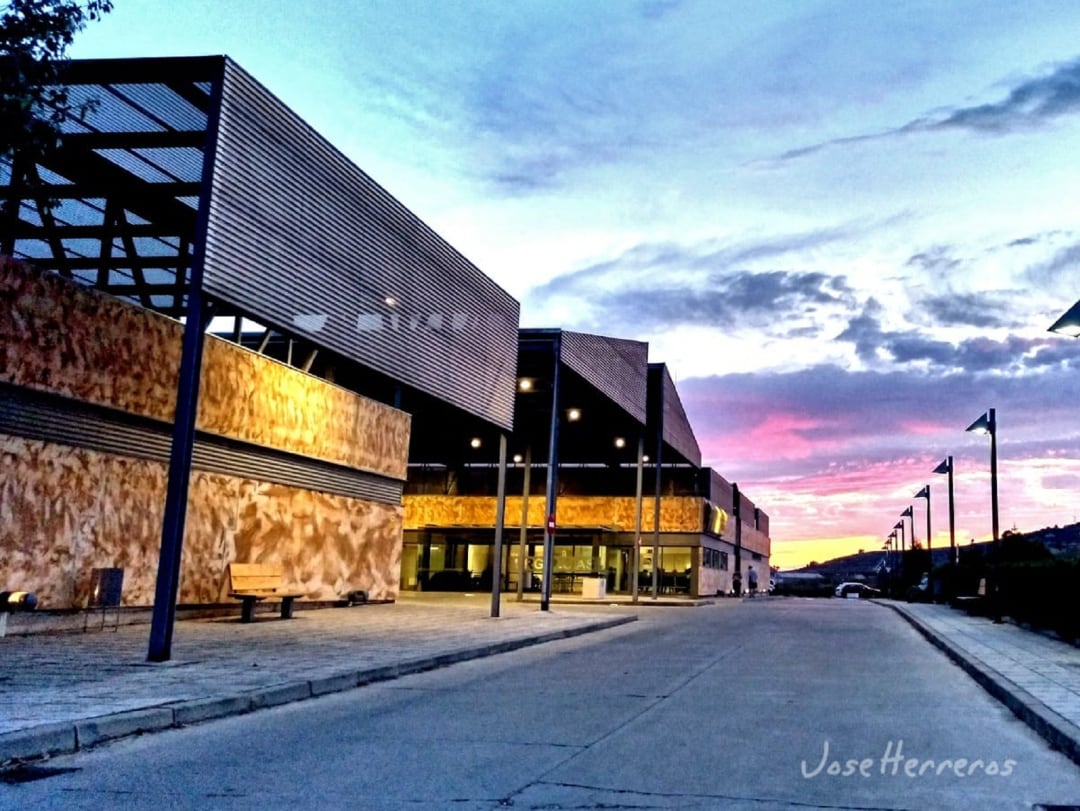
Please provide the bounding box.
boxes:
[0,616,637,767]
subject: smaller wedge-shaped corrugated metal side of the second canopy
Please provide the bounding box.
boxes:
[562,329,649,424]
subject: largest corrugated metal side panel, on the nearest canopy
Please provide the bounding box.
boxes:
[203,59,518,429]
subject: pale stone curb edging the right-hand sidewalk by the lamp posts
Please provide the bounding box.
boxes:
[879,603,1080,766]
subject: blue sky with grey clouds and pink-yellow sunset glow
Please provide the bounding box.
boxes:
[69,0,1080,568]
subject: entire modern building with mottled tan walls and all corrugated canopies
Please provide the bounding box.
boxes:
[0,56,769,639]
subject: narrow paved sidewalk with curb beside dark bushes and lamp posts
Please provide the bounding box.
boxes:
[877,599,1080,763]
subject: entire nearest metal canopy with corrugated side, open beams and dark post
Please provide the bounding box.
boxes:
[0,56,519,661]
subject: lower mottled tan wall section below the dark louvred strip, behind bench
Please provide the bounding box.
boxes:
[0,435,403,609]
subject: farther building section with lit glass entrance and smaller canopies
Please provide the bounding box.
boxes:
[402,329,769,596]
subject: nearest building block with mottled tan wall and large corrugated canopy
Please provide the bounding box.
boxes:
[0,56,518,647]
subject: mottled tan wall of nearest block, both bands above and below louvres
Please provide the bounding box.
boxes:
[0,260,409,608]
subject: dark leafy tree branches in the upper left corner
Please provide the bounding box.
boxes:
[0,0,112,165]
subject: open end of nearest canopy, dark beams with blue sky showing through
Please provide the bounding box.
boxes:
[0,58,213,317]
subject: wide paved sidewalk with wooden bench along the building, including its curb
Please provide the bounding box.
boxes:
[0,596,636,765]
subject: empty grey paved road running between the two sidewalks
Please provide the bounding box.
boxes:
[0,598,1080,811]
